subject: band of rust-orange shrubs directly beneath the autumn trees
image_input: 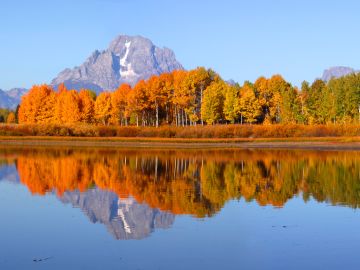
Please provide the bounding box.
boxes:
[0,124,360,139]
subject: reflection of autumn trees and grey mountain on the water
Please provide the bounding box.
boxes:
[0,148,360,239]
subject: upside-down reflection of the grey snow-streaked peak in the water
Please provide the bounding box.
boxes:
[59,188,175,240]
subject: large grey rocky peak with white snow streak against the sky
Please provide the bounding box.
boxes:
[51,35,183,92]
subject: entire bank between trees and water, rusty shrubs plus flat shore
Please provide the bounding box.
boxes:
[0,124,360,150]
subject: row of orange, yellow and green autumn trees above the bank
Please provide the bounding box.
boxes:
[16,67,360,127]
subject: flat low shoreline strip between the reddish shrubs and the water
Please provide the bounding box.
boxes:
[0,136,360,151]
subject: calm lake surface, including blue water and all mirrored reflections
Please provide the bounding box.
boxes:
[0,148,360,270]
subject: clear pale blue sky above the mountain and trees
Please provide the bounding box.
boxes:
[0,0,360,89]
